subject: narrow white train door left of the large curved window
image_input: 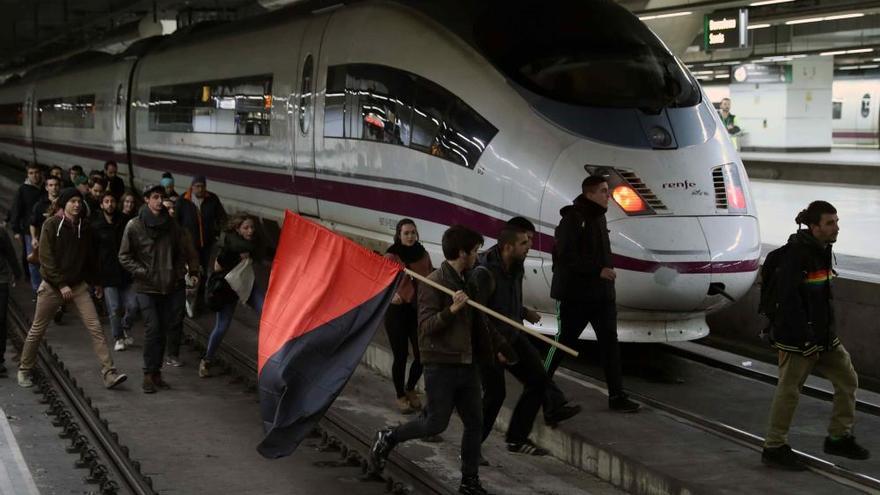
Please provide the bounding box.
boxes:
[290,17,328,217]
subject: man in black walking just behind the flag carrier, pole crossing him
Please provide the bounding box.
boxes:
[469,223,580,455]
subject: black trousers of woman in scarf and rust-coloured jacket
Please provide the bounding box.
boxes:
[385,304,422,398]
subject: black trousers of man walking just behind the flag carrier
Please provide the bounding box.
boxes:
[480,336,558,443]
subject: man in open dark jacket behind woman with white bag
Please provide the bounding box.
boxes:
[176,175,226,318]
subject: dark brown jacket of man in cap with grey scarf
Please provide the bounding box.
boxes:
[119,207,199,294]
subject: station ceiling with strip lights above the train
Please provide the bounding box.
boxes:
[0,0,880,75]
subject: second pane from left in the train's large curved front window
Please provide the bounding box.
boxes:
[346,65,412,146]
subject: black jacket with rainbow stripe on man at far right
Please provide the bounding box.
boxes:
[770,230,840,356]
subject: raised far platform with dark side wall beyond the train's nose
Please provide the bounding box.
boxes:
[740,148,880,186]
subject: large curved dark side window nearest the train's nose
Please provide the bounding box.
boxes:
[324,64,498,168]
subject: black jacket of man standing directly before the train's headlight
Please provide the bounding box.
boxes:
[550,195,616,303]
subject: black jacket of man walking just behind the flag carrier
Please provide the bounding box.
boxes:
[468,244,525,343]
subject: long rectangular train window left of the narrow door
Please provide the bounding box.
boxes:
[149,74,272,136]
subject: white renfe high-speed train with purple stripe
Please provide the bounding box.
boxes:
[0,0,760,342]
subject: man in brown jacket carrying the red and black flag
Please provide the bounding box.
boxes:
[369,225,516,494]
